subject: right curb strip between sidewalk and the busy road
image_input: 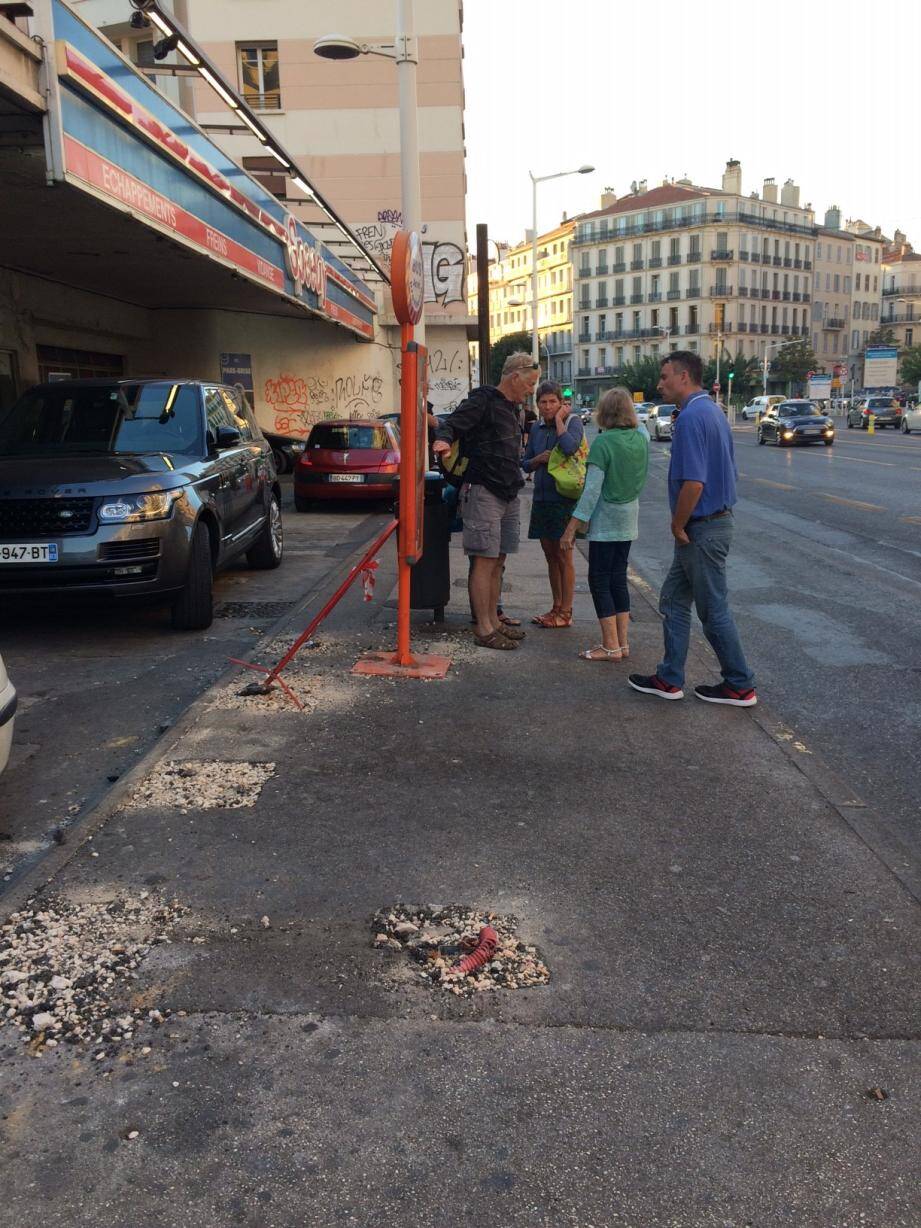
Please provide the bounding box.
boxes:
[630,565,921,904]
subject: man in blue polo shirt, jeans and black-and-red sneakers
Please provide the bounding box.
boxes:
[629,350,758,707]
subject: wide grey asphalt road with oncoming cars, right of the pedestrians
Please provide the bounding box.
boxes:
[631,424,921,850]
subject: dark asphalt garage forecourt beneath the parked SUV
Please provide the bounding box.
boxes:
[0,478,386,889]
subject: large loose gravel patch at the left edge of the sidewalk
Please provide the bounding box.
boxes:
[0,892,185,1060]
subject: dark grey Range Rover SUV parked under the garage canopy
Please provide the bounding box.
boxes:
[0,379,284,630]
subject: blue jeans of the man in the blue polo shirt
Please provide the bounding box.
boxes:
[656,513,755,691]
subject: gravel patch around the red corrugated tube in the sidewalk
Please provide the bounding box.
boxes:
[371,904,550,997]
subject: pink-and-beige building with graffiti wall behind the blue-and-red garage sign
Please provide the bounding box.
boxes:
[77,0,470,419]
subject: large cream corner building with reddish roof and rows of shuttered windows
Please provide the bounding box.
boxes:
[572,161,815,400]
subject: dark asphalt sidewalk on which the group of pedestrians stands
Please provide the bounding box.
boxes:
[0,491,921,1228]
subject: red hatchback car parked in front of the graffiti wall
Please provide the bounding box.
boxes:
[295,418,400,512]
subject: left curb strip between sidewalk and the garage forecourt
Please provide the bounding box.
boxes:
[0,525,390,921]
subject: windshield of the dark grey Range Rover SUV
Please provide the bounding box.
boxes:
[0,383,203,456]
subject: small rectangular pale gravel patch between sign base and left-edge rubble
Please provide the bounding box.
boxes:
[124,759,275,813]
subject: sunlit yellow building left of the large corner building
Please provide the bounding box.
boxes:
[468,220,575,384]
